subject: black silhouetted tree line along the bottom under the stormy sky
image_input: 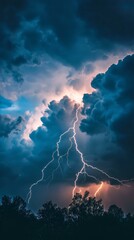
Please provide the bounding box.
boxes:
[0,192,134,240]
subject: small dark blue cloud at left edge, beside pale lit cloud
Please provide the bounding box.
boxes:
[0,115,23,137]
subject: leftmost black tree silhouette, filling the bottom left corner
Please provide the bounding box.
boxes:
[0,196,36,240]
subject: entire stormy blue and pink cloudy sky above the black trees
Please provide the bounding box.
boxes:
[0,0,134,212]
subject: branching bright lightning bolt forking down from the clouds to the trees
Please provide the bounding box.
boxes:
[26,105,134,204]
